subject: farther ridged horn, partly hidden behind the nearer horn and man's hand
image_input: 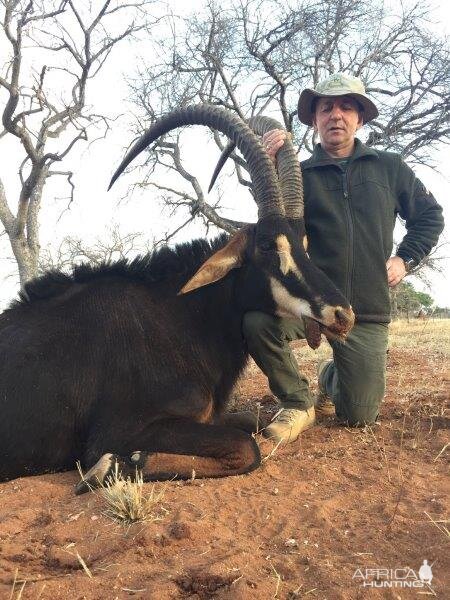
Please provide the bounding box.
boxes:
[208,116,304,219]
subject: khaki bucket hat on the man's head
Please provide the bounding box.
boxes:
[298,73,378,125]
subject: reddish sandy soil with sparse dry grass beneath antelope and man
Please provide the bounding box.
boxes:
[0,322,450,600]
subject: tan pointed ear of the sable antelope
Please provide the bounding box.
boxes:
[178,228,248,295]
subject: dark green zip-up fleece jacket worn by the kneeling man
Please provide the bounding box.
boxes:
[301,140,444,323]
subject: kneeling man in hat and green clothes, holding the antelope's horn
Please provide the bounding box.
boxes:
[243,73,443,443]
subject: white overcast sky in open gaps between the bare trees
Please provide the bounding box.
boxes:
[0,0,450,308]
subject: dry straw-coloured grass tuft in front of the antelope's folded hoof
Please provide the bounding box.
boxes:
[97,463,167,525]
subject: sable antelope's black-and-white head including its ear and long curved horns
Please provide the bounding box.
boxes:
[110,105,354,341]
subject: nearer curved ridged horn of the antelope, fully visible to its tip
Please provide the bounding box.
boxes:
[108,104,284,219]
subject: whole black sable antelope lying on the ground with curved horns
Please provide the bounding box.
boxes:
[0,105,354,493]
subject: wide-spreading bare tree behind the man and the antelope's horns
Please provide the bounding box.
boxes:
[126,0,450,238]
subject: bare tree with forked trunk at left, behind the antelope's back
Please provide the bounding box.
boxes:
[0,0,158,285]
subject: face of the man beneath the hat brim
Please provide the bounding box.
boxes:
[313,96,363,150]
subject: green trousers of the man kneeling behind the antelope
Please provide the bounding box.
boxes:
[242,311,388,426]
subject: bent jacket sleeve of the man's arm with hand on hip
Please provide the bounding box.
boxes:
[397,161,444,263]
